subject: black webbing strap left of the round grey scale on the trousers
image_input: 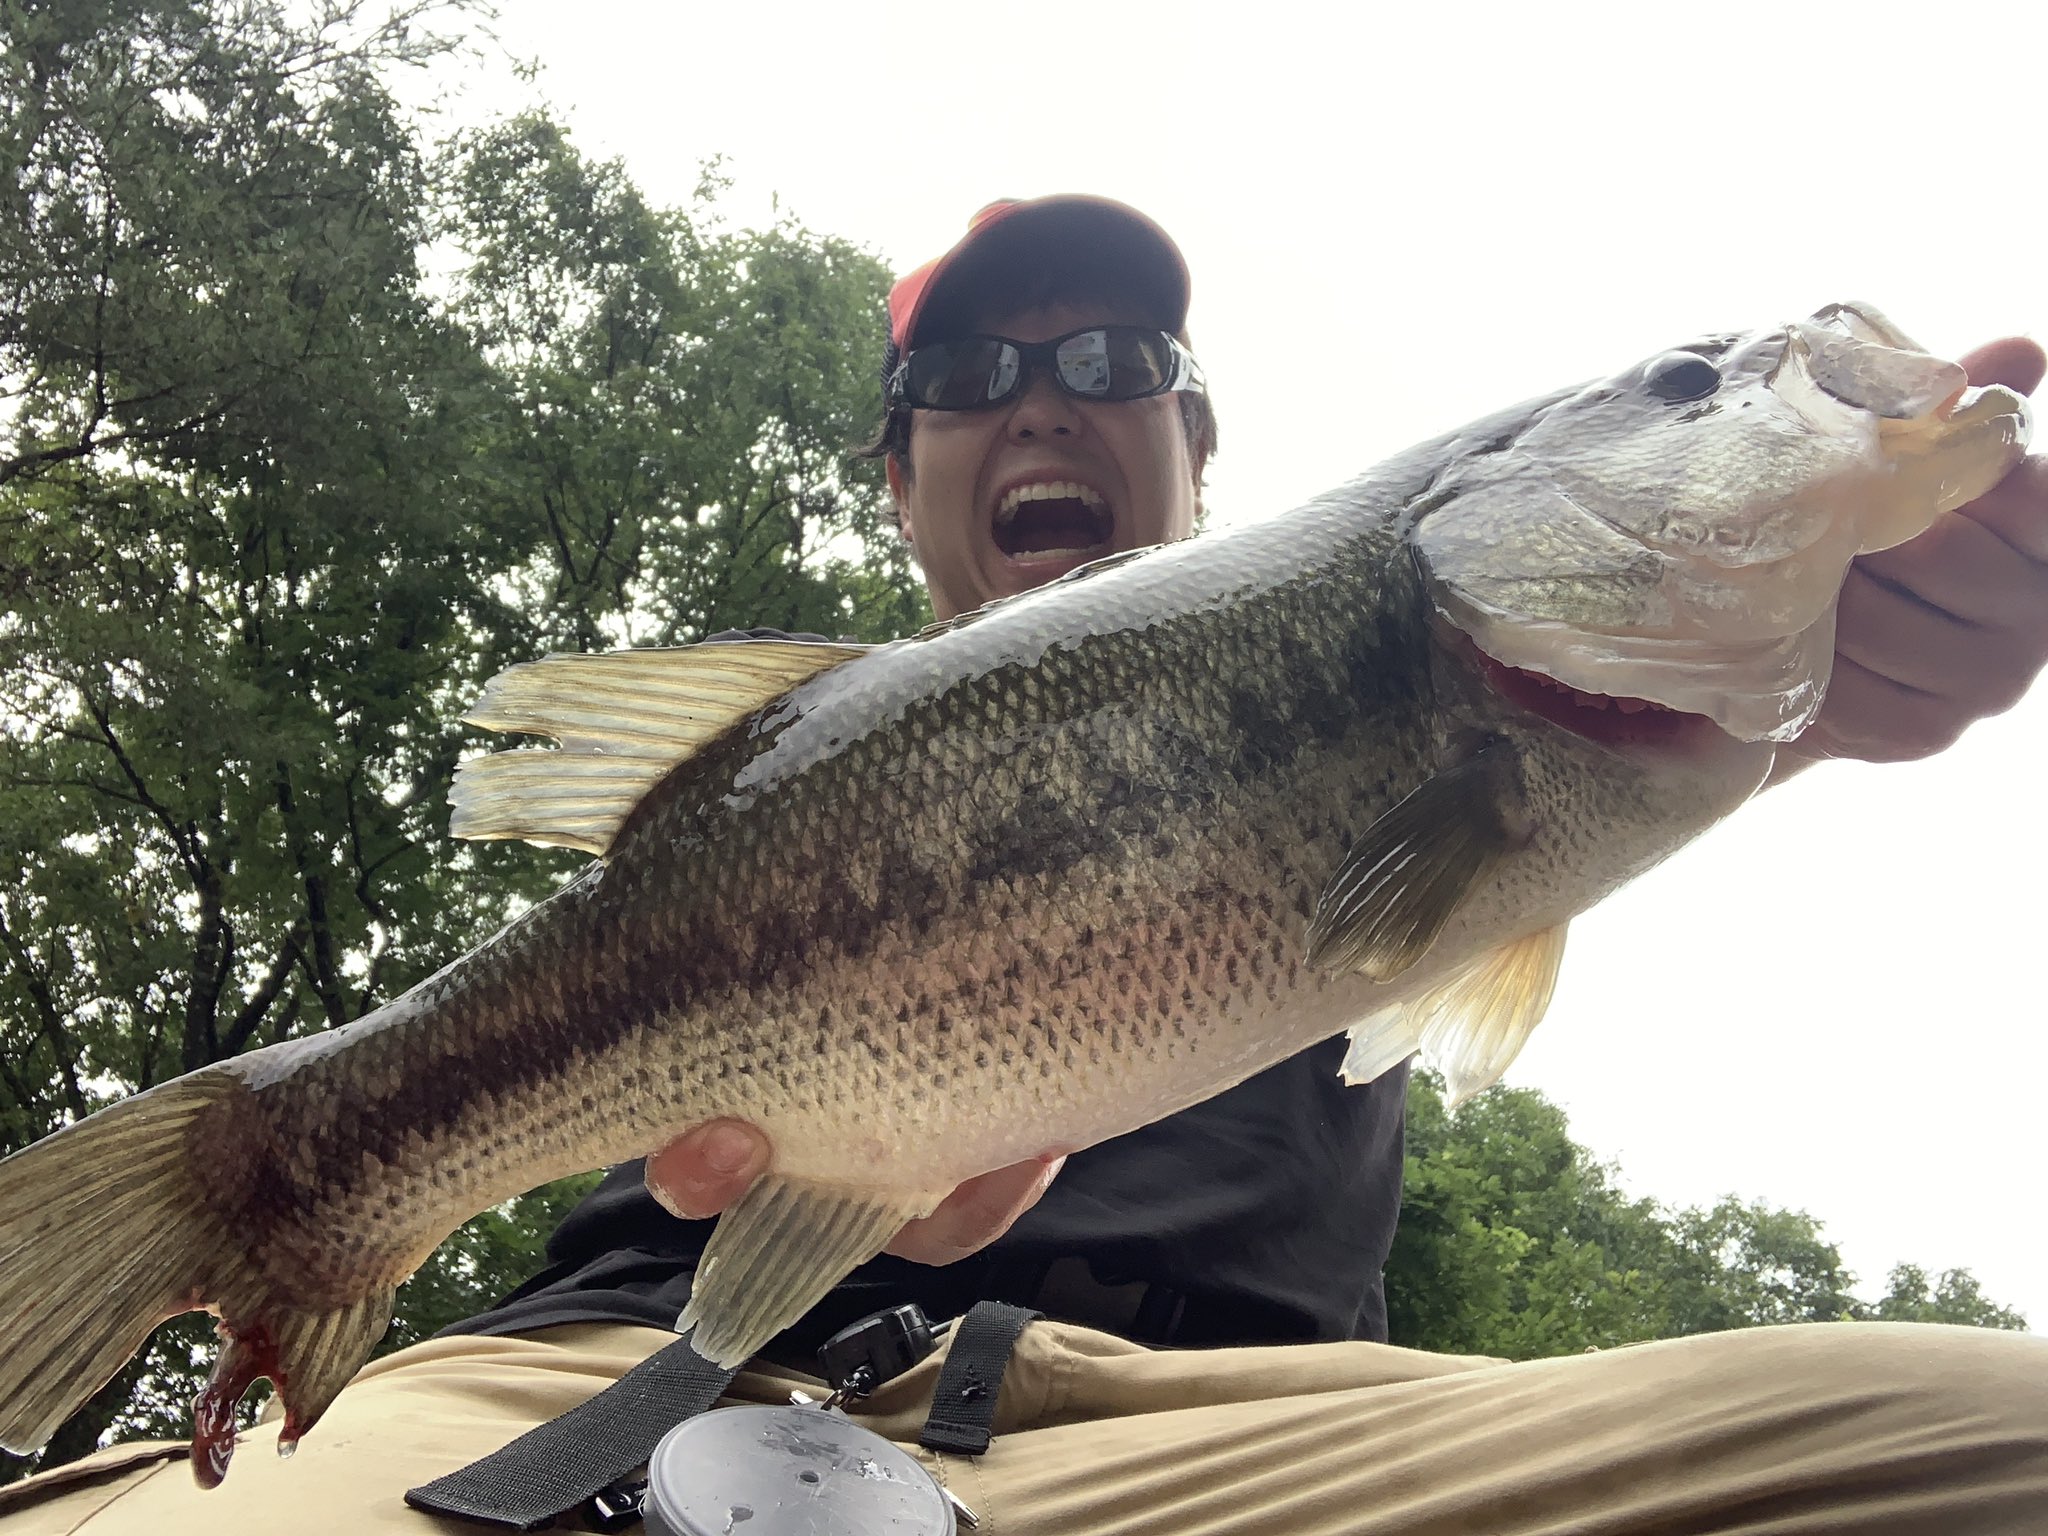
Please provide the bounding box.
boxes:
[406,1339,739,1530]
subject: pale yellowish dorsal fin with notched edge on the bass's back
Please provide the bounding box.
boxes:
[449,641,868,854]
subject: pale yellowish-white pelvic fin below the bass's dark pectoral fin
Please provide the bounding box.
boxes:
[1339,924,1565,1108]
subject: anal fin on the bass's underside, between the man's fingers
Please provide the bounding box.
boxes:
[676,1174,946,1366]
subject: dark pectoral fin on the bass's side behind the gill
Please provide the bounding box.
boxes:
[1309,743,1526,981]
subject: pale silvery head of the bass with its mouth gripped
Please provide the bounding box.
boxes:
[1411,305,2028,741]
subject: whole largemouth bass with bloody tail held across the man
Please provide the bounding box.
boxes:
[0,307,2028,1483]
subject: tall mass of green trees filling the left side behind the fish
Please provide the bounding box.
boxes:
[0,0,922,1490]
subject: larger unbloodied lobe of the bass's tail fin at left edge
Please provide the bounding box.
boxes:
[0,1077,240,1454]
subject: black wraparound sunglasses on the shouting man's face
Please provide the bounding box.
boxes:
[889,326,1208,412]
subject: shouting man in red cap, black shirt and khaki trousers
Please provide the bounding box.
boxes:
[0,199,2048,1536]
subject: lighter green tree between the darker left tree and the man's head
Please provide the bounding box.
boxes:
[446,115,928,649]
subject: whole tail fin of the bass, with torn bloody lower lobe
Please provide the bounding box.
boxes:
[0,1069,393,1485]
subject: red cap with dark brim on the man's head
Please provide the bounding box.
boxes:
[889,193,1190,352]
